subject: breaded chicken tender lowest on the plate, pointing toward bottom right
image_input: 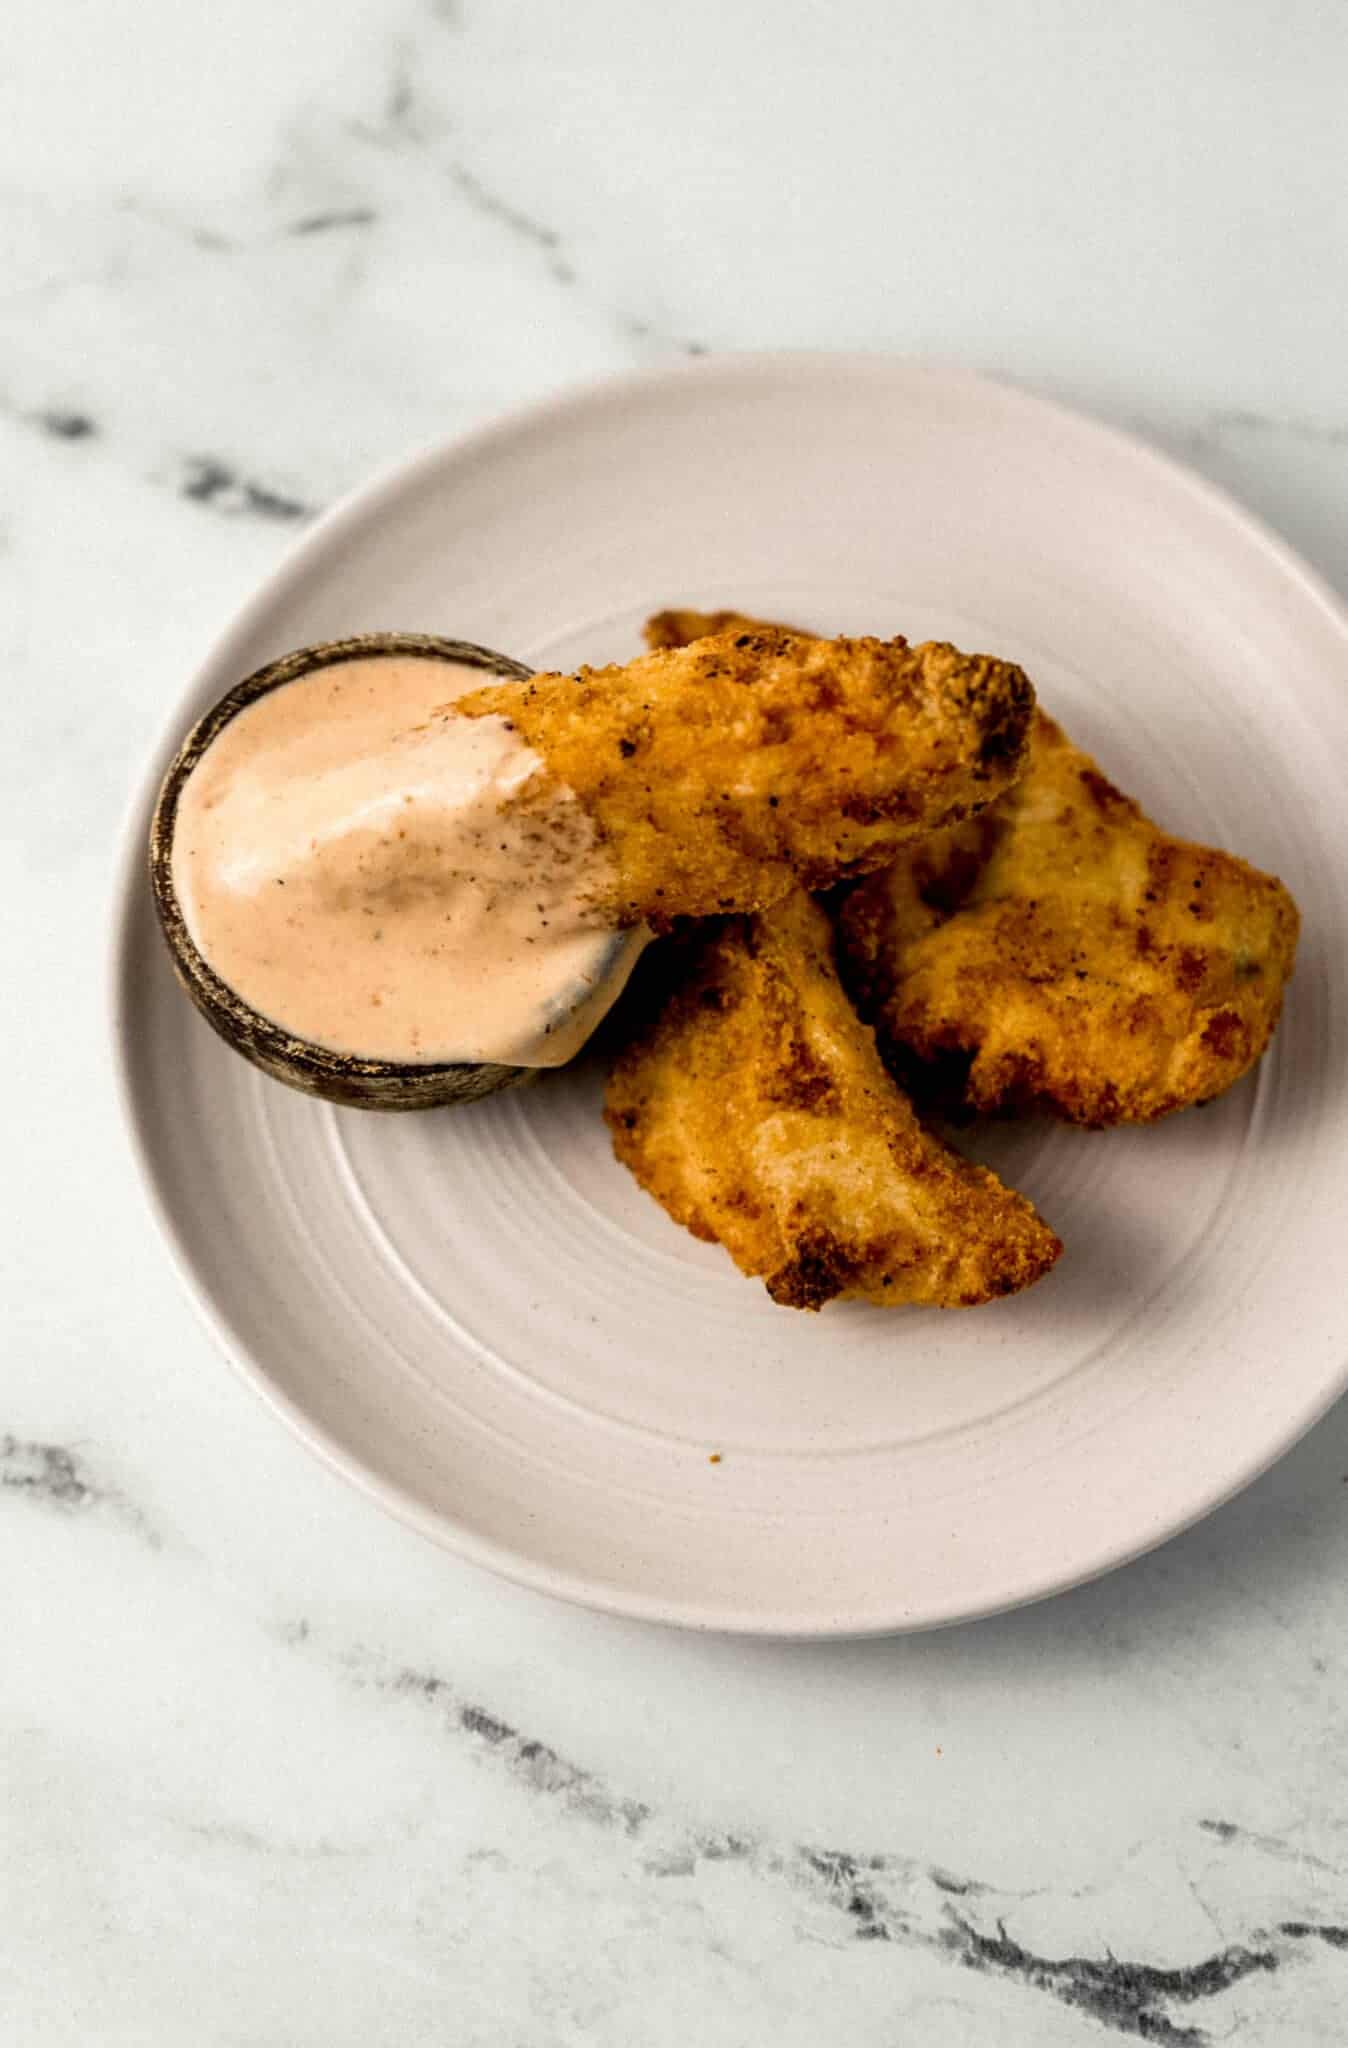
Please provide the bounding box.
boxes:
[604,889,1061,1309]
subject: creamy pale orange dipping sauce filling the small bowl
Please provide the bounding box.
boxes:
[172,653,647,1067]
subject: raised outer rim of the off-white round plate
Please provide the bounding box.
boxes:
[104,348,1348,1640]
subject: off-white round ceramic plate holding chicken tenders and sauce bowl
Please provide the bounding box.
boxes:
[117,356,1348,1636]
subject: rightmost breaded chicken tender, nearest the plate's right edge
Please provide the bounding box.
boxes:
[840,713,1299,1126]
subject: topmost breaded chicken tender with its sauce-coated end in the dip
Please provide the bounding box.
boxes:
[455,629,1035,924]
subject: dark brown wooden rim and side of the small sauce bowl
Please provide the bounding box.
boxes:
[150,633,535,1110]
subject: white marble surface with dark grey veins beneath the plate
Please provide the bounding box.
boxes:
[0,0,1348,2048]
